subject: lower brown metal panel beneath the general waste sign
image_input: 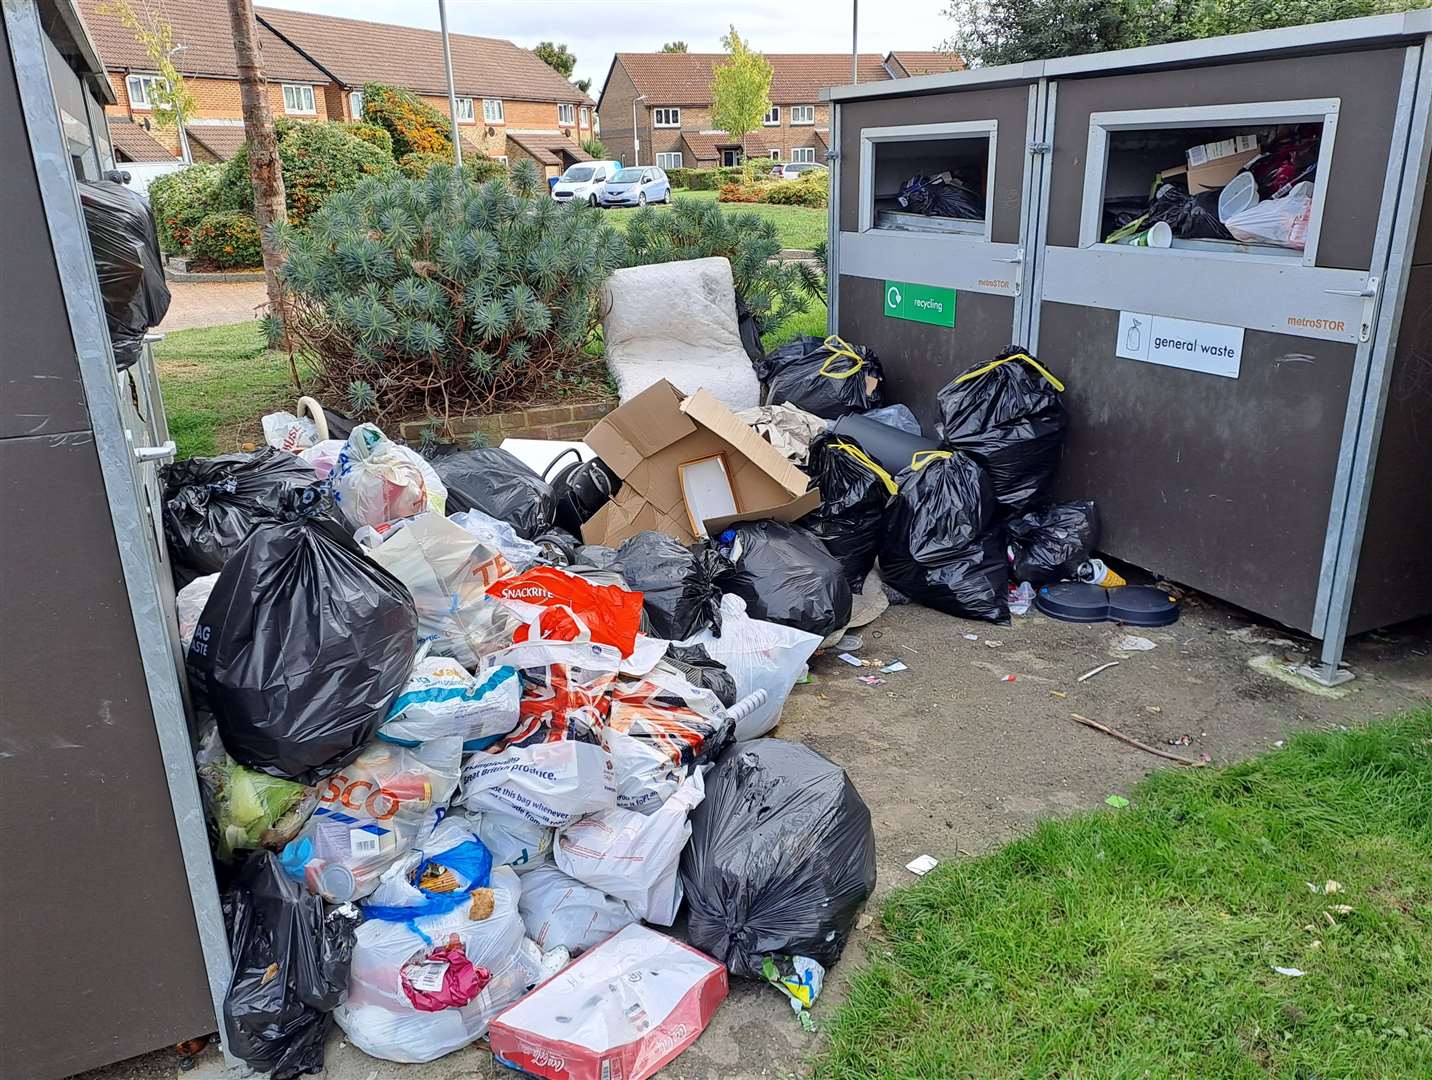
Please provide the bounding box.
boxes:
[1040,304,1355,630]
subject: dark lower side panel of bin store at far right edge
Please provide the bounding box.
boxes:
[1348,262,1432,633]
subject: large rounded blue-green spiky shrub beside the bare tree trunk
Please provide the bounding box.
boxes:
[278,162,623,421]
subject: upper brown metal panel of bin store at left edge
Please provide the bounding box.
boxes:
[0,32,89,438]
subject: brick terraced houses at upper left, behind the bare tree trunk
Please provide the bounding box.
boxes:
[79,0,596,176]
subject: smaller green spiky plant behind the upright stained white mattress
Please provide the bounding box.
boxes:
[623,199,809,334]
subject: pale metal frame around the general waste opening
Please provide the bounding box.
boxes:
[1082,97,1342,266]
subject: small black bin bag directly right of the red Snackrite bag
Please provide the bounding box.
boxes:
[616,531,732,642]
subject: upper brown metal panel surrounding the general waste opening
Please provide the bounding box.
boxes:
[1048,47,1406,269]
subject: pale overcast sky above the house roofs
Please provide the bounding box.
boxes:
[259,0,952,97]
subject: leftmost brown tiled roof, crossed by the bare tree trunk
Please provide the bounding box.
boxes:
[79,0,328,83]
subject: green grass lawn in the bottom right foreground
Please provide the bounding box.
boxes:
[816,710,1432,1080]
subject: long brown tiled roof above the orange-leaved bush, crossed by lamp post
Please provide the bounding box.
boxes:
[255,7,591,105]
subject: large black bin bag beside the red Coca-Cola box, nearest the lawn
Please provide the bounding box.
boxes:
[682,739,875,978]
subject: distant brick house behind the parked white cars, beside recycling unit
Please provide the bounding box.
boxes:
[597,53,961,169]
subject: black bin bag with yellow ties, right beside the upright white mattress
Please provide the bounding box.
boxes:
[756,335,885,420]
